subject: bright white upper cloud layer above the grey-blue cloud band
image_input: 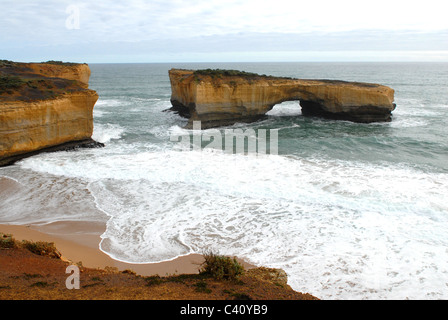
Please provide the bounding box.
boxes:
[0,0,448,42]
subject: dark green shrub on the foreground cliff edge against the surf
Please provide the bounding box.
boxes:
[199,252,244,280]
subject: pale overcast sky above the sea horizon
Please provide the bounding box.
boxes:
[0,0,448,63]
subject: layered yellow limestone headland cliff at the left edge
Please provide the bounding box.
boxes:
[0,61,101,166]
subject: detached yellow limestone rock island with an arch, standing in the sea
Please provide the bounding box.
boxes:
[169,69,395,128]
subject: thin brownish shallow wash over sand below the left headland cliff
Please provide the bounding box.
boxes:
[0,168,104,224]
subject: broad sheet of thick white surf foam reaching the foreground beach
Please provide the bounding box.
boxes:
[16,146,448,299]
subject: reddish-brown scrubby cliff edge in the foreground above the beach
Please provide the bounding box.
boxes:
[0,232,319,300]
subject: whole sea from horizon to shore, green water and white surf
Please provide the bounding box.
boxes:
[0,63,448,299]
